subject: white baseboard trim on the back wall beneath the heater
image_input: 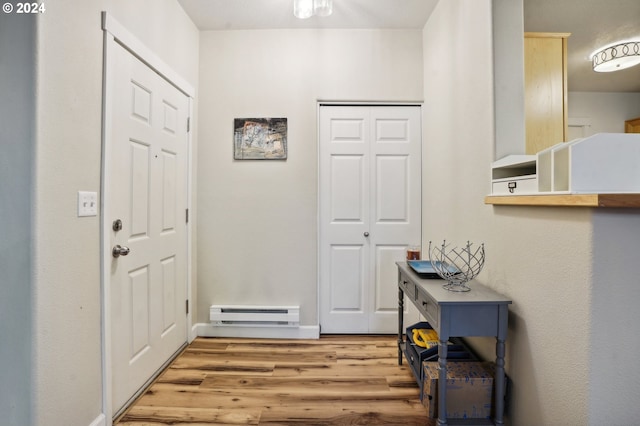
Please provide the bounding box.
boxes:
[192,323,320,339]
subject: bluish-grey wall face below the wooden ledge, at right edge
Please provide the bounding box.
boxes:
[588,209,640,426]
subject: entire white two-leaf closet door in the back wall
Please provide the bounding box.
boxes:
[319,105,422,333]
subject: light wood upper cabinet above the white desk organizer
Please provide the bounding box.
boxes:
[524,33,570,154]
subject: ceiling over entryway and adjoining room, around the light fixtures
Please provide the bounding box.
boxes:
[179,0,640,92]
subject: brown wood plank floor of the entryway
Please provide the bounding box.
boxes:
[115,335,436,426]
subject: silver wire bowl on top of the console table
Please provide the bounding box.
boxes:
[429,240,484,291]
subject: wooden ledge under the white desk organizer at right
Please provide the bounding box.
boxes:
[484,194,640,208]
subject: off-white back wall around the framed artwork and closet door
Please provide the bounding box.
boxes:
[197,30,423,325]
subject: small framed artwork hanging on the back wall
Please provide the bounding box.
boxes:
[233,118,287,160]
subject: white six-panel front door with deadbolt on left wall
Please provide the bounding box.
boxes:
[104,43,189,413]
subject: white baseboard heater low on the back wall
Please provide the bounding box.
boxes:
[209,305,300,327]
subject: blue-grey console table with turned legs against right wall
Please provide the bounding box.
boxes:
[396,262,511,426]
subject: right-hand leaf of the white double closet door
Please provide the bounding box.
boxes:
[369,107,422,333]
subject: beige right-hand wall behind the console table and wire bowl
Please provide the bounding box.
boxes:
[423,0,593,426]
